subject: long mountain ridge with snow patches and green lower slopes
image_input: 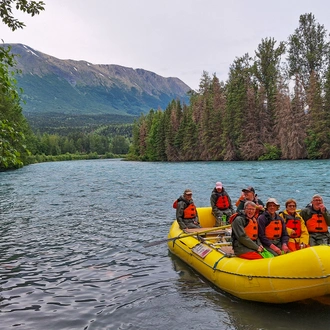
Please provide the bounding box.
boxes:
[5,44,190,124]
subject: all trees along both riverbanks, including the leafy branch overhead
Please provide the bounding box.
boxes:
[0,9,330,171]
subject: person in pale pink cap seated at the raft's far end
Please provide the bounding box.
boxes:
[210,182,234,227]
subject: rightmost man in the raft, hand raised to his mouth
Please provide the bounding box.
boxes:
[300,195,330,246]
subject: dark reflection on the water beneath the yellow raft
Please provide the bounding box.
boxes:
[169,253,330,330]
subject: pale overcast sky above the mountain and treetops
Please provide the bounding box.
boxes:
[0,0,330,90]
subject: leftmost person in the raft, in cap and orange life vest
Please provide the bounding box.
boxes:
[176,189,201,229]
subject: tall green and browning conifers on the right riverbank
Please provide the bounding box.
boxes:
[129,13,330,161]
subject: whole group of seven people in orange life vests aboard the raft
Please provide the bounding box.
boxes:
[173,182,330,259]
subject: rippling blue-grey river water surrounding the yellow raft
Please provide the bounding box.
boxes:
[0,160,330,330]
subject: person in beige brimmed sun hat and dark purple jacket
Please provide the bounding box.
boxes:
[258,198,290,256]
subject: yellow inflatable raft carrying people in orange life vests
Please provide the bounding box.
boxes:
[168,207,330,304]
